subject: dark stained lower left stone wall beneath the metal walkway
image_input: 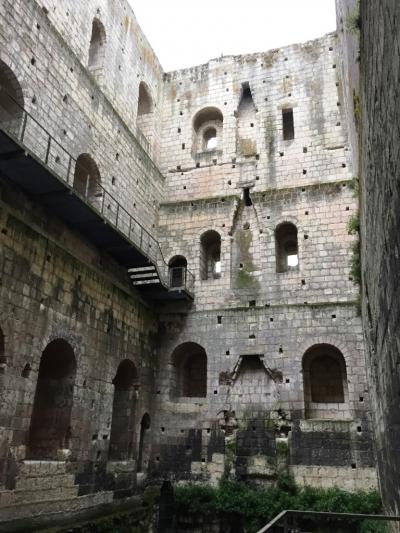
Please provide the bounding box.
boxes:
[0,178,157,520]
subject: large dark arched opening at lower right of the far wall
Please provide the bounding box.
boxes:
[303,344,349,419]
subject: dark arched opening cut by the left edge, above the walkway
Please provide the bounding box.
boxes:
[0,61,24,136]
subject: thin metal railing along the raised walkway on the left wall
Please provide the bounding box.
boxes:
[0,85,194,292]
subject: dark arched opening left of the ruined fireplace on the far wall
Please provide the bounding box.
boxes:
[172,342,207,398]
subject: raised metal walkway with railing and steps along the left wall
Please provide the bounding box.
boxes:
[0,86,194,300]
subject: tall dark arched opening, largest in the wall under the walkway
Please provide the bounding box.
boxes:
[29,339,76,460]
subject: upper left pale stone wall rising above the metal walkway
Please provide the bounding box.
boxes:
[0,0,164,233]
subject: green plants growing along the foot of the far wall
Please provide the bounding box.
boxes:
[175,474,386,533]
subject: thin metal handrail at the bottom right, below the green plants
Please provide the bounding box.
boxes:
[258,510,400,533]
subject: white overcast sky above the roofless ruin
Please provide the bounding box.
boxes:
[128,0,336,71]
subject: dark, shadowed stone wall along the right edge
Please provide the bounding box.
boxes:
[337,0,400,514]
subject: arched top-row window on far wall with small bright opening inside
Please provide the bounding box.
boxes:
[193,107,224,153]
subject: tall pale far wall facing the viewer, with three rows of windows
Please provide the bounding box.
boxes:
[154,35,376,489]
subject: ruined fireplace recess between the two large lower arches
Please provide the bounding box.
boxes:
[230,354,277,411]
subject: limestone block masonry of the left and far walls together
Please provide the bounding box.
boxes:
[0,0,377,531]
